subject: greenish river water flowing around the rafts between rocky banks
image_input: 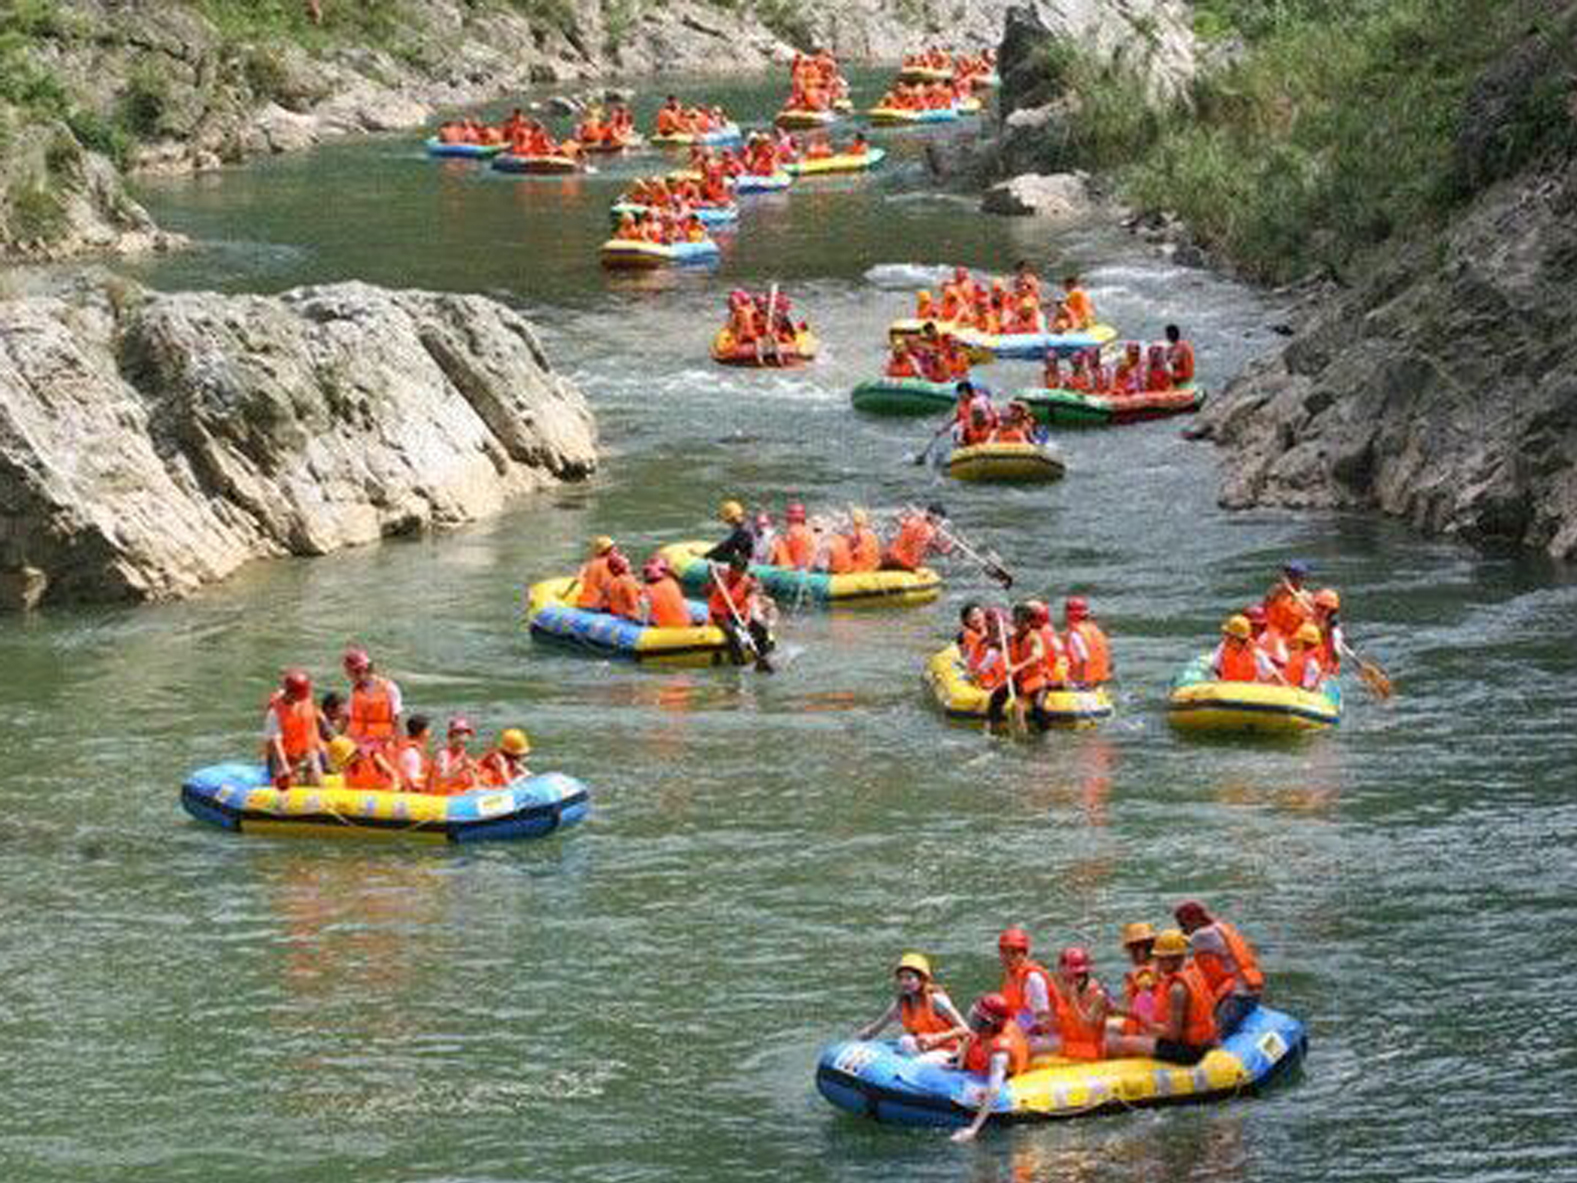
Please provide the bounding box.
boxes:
[0,69,1577,1181]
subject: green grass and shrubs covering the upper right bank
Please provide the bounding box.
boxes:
[1047,0,1574,281]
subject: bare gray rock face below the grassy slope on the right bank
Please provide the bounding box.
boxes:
[1200,159,1577,558]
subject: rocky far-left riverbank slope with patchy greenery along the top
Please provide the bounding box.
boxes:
[0,0,1191,257]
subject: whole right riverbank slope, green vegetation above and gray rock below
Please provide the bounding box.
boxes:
[1000,0,1577,558]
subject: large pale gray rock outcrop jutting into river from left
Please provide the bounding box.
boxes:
[0,284,596,606]
